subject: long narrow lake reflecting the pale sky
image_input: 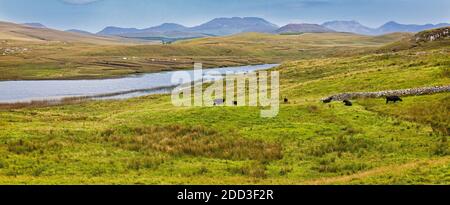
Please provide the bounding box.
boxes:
[0,64,278,103]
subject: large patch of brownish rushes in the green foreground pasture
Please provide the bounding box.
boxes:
[100,125,282,161]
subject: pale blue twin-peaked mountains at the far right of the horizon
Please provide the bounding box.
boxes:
[322,21,450,35]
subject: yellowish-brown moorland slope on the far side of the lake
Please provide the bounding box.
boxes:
[0,28,410,80]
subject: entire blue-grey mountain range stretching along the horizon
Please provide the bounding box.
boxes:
[23,17,450,39]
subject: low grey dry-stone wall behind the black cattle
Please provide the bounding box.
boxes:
[322,85,450,102]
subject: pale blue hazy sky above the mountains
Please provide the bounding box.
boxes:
[0,0,450,32]
